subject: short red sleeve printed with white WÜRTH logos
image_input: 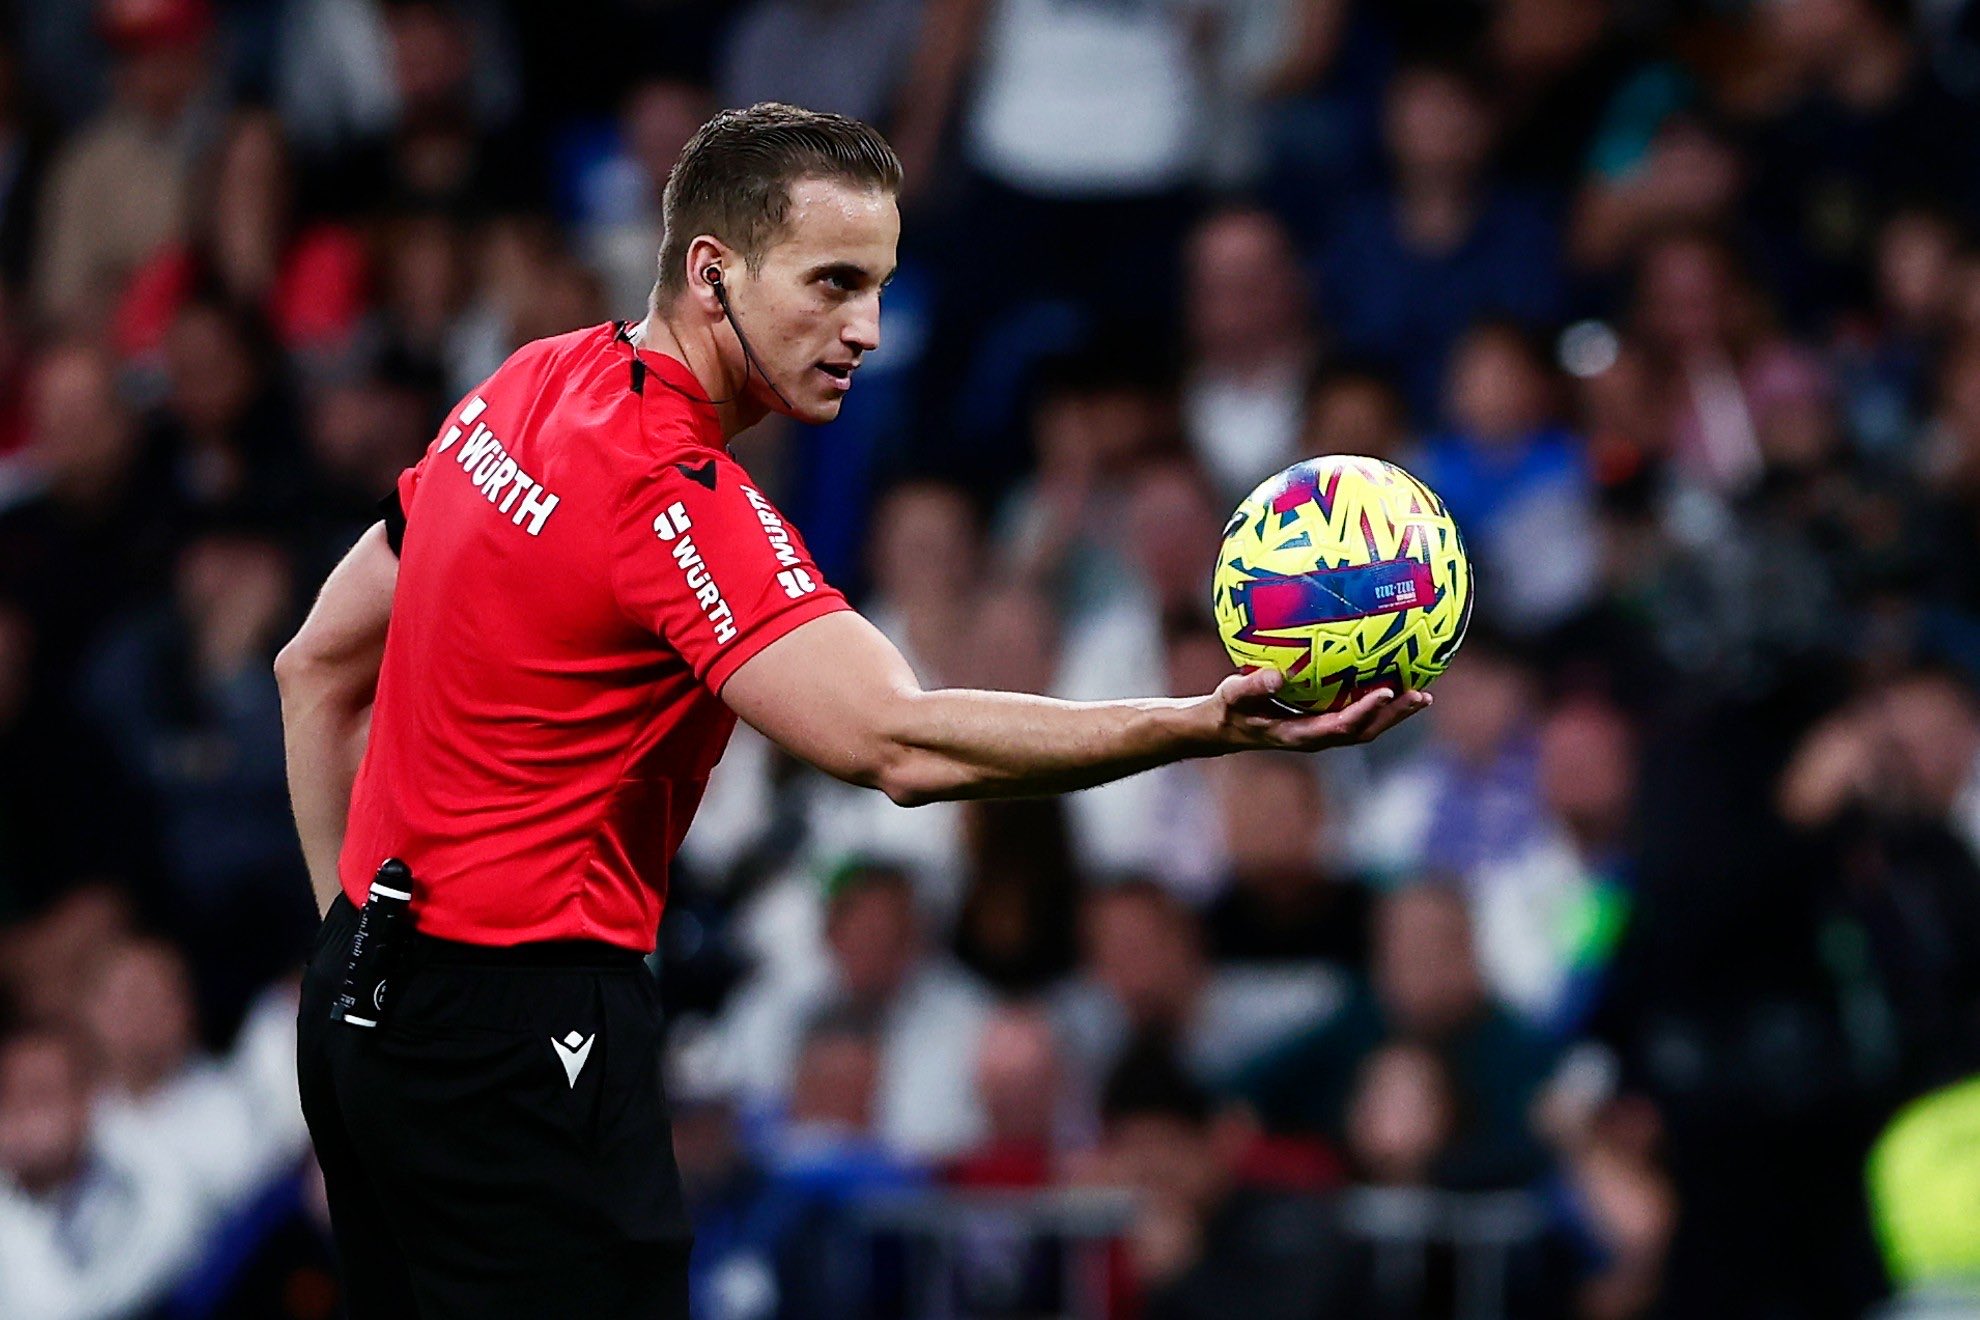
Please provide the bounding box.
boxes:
[612,453,847,693]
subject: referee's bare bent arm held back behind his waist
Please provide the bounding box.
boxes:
[275,522,398,912]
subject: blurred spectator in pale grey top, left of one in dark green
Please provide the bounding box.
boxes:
[1053,881,1338,1086]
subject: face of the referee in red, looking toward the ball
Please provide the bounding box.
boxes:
[723,178,901,425]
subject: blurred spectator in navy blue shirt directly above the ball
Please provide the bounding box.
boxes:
[1321,65,1562,418]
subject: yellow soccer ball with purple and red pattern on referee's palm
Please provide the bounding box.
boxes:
[1212,453,1471,710]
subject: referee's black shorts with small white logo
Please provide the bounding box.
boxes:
[297,898,691,1320]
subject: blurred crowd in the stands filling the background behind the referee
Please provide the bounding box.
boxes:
[0,0,1980,1320]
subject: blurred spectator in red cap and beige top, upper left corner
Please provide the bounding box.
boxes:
[34,0,216,332]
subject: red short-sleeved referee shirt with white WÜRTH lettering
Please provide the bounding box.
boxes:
[339,325,845,950]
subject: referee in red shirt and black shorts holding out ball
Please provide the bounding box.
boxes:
[275,105,1430,1320]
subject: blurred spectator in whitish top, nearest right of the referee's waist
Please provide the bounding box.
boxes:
[723,863,988,1160]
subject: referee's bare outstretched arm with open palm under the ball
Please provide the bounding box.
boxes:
[723,610,1430,805]
